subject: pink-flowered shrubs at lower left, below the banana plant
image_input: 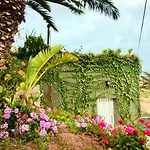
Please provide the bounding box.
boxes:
[0,106,64,140]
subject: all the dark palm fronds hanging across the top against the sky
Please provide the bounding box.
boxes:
[26,0,119,31]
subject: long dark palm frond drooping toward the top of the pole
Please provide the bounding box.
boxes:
[26,0,58,31]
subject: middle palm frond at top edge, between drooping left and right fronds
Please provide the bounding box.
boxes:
[46,0,83,15]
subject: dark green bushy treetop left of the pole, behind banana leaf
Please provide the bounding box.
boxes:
[14,34,48,60]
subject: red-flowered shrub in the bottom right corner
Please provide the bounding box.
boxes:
[102,120,150,150]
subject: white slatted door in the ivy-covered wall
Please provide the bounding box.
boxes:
[97,99,114,125]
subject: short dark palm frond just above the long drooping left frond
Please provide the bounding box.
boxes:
[26,0,51,12]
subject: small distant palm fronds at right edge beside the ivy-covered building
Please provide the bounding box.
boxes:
[141,72,150,90]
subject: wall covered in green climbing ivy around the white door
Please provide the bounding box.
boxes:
[45,50,141,118]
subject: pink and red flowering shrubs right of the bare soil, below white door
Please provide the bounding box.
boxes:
[70,114,150,150]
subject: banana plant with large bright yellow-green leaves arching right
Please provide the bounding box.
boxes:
[19,45,78,104]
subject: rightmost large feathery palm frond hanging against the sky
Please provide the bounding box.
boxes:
[80,0,120,20]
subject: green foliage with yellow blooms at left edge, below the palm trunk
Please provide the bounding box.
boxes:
[0,55,26,107]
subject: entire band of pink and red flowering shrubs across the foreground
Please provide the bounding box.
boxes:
[0,105,150,150]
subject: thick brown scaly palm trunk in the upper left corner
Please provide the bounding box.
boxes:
[0,0,25,70]
